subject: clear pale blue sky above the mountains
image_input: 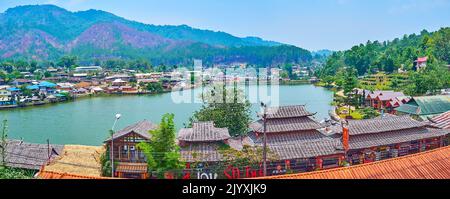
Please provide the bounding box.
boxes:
[0,0,450,50]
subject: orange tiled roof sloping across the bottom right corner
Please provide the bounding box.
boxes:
[259,146,450,179]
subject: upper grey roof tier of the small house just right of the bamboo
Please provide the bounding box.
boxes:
[178,122,231,142]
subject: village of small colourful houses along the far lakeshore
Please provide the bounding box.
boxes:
[0,60,318,109]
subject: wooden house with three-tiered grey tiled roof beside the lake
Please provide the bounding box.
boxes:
[249,105,344,175]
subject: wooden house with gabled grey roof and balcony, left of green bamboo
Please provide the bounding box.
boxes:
[105,120,157,178]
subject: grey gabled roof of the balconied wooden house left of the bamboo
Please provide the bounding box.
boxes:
[105,120,158,142]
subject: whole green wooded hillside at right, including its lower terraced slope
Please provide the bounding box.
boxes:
[317,28,450,95]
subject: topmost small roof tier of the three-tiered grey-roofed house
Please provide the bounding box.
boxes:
[266,105,314,119]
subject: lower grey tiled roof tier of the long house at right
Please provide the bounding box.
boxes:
[349,128,450,149]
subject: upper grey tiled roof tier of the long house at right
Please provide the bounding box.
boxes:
[342,116,425,135]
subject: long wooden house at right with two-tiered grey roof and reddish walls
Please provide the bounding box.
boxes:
[336,114,449,165]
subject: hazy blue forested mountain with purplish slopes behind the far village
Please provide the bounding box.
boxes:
[0,5,312,65]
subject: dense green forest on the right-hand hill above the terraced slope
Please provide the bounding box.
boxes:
[320,28,450,76]
